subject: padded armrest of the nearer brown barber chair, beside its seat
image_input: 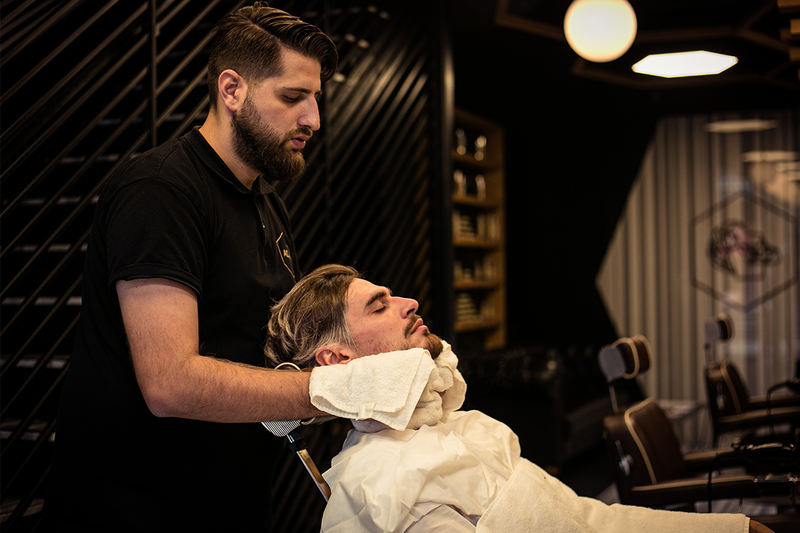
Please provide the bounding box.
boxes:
[630,476,761,507]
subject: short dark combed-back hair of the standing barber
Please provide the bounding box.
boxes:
[208,2,339,107]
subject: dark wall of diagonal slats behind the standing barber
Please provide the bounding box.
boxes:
[0,0,446,531]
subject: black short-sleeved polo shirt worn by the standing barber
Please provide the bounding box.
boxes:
[45,129,299,531]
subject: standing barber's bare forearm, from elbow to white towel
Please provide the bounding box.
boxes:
[140,355,325,422]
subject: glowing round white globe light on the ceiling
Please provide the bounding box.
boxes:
[564,0,636,63]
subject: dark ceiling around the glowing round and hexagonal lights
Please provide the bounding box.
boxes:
[452,0,800,112]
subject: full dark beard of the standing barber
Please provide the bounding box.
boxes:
[232,98,311,181]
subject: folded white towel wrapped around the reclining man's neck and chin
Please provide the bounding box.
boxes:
[308,342,467,433]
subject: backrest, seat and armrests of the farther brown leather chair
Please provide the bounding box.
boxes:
[705,359,800,445]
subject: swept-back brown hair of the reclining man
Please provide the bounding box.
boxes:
[264,265,361,367]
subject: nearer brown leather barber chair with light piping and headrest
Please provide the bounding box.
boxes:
[598,336,798,516]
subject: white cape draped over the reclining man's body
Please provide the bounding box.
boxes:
[312,343,749,533]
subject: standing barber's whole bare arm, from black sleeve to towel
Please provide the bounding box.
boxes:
[116,279,322,422]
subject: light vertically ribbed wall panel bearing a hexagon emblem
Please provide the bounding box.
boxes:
[597,110,800,444]
